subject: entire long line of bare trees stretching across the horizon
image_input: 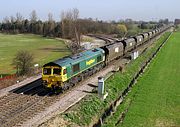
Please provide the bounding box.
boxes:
[0,8,168,44]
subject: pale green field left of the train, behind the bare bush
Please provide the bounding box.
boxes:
[0,33,70,74]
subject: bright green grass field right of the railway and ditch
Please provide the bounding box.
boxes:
[122,32,180,127]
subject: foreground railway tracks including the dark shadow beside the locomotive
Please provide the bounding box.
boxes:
[0,78,88,127]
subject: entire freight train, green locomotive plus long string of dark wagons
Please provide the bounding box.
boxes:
[42,26,170,90]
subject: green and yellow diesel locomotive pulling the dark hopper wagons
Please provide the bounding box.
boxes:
[42,48,105,89]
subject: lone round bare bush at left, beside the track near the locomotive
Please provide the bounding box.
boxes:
[12,50,34,75]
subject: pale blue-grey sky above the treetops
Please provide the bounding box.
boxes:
[0,0,180,21]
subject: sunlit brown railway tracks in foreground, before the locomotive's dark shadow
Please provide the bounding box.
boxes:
[0,90,66,127]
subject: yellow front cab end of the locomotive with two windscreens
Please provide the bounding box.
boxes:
[42,63,67,88]
